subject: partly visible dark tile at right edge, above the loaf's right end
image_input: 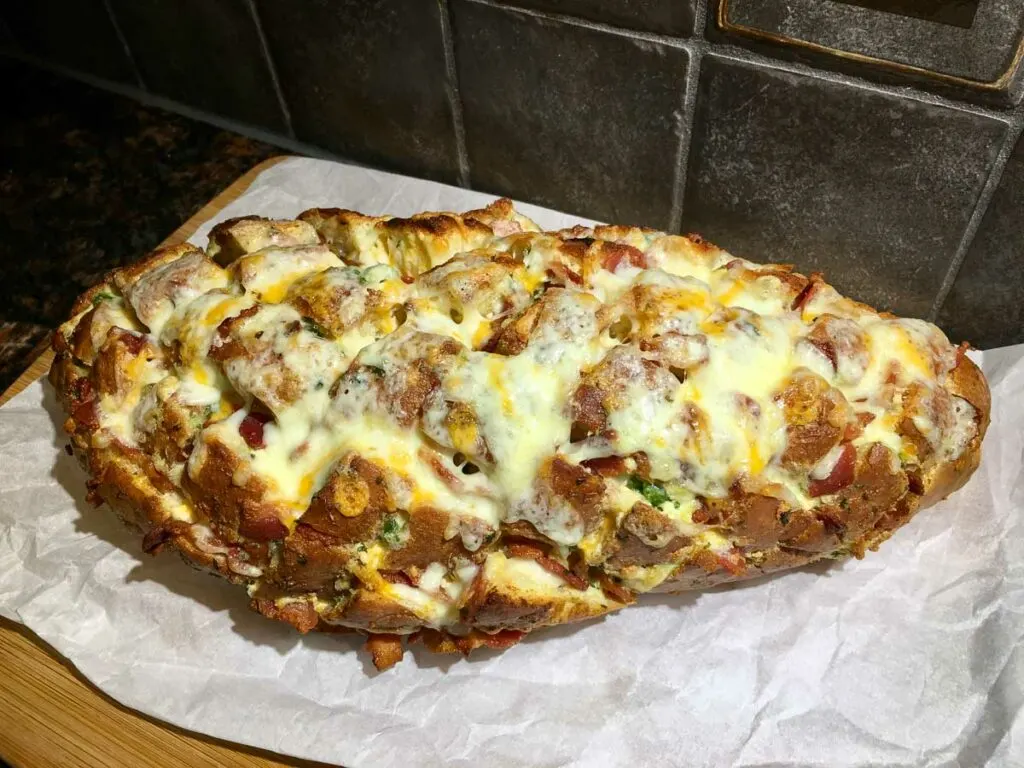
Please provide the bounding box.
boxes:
[938,140,1024,348]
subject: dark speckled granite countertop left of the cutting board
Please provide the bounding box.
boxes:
[0,57,283,391]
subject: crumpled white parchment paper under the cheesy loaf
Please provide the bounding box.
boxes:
[0,160,1024,768]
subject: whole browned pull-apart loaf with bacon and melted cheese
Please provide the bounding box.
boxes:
[50,200,989,668]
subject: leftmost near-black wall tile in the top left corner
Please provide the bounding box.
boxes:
[3,0,135,85]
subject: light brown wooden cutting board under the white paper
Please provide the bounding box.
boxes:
[0,157,331,768]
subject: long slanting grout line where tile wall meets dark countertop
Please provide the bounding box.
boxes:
[0,50,344,165]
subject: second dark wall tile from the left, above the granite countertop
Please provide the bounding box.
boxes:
[111,0,285,132]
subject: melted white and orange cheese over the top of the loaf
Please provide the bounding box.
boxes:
[83,204,975,627]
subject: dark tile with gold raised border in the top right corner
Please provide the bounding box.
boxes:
[709,0,1024,101]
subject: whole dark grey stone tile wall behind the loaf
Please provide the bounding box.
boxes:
[0,0,1024,346]
